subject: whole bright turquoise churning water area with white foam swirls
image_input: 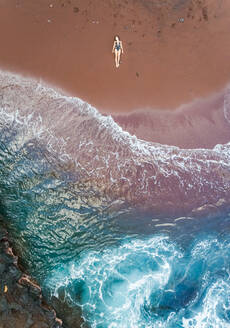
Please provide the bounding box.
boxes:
[45,235,230,328]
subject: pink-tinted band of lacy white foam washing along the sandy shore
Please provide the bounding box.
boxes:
[0,72,230,211]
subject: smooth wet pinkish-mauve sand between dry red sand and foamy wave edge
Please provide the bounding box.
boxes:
[113,89,230,148]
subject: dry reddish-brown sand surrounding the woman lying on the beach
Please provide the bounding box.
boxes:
[0,0,230,113]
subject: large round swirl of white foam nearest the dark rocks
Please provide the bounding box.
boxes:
[45,236,180,328]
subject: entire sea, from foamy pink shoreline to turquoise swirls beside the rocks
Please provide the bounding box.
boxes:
[0,72,230,328]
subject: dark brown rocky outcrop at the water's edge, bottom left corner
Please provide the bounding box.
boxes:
[0,226,62,328]
